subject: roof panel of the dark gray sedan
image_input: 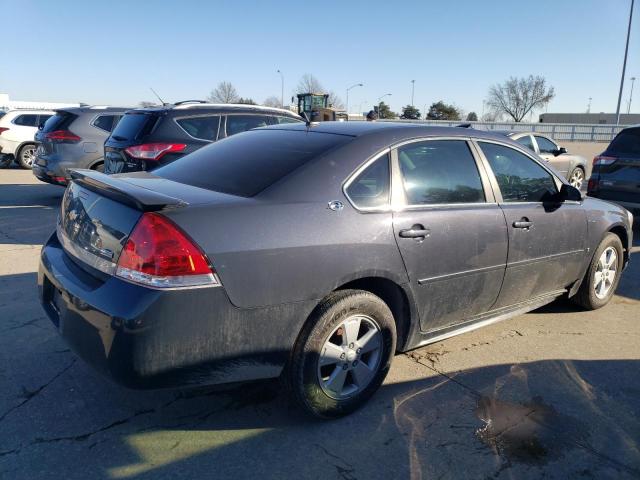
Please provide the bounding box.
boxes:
[262,121,516,140]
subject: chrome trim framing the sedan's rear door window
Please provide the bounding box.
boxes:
[392,136,490,211]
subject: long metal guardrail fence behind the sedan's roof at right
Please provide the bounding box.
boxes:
[350,115,626,142]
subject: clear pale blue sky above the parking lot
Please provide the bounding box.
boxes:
[0,0,640,114]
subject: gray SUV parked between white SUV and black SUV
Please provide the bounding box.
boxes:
[33,106,129,185]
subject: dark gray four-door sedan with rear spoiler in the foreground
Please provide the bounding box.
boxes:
[38,122,633,417]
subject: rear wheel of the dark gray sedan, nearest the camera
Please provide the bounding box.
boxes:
[285,290,396,418]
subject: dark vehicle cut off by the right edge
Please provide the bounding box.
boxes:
[587,125,640,212]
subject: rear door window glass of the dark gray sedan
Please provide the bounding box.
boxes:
[398,140,485,205]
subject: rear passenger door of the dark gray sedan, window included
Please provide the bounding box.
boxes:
[393,139,507,331]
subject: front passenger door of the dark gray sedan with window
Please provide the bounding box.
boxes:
[478,141,587,308]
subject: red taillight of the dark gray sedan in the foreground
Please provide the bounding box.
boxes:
[116,213,220,288]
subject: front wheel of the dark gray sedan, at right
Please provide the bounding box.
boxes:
[573,233,624,310]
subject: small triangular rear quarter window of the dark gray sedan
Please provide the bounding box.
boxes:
[345,154,390,208]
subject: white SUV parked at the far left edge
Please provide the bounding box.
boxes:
[0,110,55,168]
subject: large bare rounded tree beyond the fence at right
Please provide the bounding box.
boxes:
[487,75,555,122]
